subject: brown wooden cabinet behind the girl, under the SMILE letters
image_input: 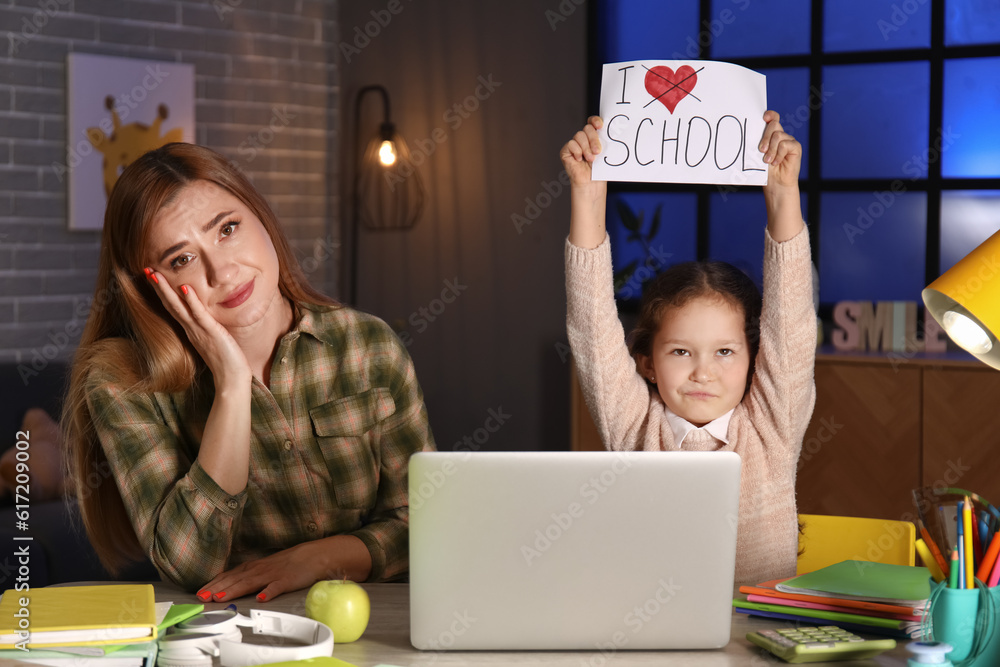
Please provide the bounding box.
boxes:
[571,352,1000,520]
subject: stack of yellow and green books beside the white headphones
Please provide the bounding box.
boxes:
[0,584,204,667]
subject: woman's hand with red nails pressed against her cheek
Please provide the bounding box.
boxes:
[145,268,253,389]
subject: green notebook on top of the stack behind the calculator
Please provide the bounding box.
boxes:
[775,560,931,607]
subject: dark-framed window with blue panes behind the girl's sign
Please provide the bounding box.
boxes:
[591,0,1000,309]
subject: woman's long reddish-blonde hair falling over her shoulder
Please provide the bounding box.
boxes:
[62,143,336,574]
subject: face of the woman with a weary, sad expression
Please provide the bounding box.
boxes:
[145,181,281,331]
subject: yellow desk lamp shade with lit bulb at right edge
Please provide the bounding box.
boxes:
[922,227,1000,370]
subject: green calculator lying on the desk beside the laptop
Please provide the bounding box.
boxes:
[747,625,896,663]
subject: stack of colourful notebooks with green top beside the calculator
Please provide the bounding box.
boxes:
[733,560,931,639]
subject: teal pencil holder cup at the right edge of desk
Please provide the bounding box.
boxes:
[930,582,1000,667]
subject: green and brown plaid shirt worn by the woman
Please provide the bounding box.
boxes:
[87,306,434,590]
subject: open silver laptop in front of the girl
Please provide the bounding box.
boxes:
[409,452,740,651]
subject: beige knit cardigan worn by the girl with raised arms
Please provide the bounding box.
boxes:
[566,228,816,583]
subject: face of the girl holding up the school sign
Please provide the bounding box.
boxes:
[640,295,750,426]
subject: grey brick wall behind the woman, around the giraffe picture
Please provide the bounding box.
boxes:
[0,0,339,370]
